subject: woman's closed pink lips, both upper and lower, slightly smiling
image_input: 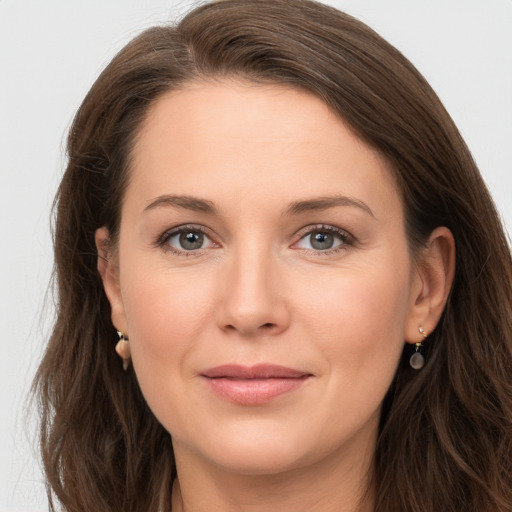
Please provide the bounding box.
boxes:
[200,364,313,405]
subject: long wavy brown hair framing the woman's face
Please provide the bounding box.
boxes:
[35,0,512,512]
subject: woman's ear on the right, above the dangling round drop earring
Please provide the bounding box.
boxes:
[405,227,455,343]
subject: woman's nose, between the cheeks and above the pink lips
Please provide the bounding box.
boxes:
[217,244,290,337]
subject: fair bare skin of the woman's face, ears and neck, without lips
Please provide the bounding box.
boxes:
[96,81,454,512]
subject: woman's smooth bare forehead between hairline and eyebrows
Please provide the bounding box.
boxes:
[128,82,400,218]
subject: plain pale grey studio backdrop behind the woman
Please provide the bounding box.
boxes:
[0,0,512,512]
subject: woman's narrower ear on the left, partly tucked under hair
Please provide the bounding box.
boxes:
[95,227,127,333]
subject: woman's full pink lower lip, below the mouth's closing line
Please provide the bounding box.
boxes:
[206,375,308,405]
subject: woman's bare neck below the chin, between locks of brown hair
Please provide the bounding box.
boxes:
[172,434,375,512]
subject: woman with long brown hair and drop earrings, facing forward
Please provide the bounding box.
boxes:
[33,0,512,512]
